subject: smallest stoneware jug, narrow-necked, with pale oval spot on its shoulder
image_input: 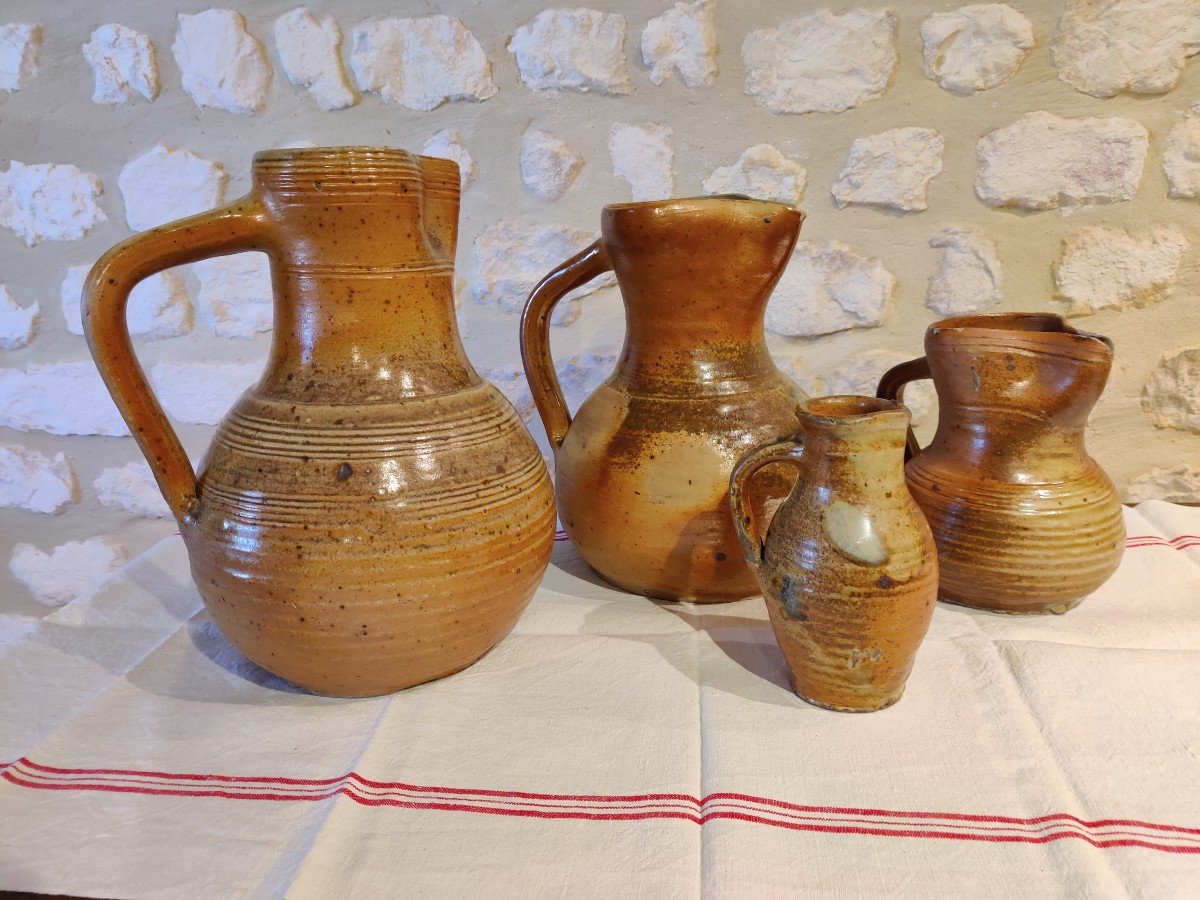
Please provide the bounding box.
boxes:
[730,396,937,712]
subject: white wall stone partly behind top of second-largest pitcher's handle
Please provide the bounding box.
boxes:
[470,221,616,325]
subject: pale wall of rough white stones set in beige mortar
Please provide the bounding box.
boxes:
[0,0,1200,640]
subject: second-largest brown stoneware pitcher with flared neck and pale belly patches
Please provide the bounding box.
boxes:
[521,197,804,601]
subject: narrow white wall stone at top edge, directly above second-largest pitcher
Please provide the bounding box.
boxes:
[642,0,716,88]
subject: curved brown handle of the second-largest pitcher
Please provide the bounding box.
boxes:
[521,241,612,450]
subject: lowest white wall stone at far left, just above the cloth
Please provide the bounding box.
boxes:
[8,538,128,606]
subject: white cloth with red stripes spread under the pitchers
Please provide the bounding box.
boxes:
[0,503,1200,898]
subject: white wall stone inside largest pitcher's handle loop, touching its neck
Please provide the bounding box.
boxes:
[196,253,275,338]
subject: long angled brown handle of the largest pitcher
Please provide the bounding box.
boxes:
[83,198,266,523]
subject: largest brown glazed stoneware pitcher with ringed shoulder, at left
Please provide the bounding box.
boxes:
[84,148,554,696]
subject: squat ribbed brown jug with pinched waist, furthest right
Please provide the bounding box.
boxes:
[878,313,1126,613]
